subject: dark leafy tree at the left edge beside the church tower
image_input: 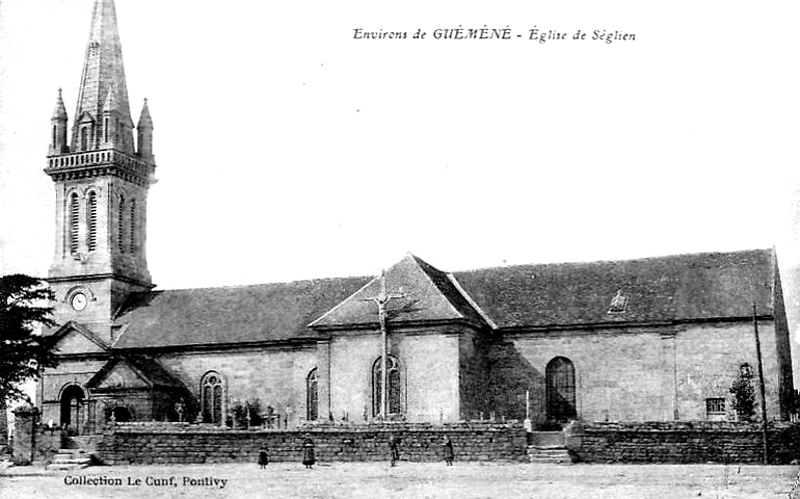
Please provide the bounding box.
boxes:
[0,274,57,405]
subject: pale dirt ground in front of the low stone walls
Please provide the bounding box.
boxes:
[0,462,798,499]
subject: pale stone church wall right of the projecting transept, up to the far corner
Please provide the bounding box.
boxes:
[488,319,791,423]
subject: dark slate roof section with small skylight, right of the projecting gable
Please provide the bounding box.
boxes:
[454,250,775,328]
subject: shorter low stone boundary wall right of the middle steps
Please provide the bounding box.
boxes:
[567,421,800,463]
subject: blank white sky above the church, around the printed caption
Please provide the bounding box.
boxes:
[0,0,800,344]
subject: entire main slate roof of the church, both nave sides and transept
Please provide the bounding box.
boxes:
[109,250,775,348]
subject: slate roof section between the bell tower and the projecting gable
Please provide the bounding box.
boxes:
[114,277,372,348]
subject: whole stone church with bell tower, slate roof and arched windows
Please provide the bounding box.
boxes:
[37,0,794,431]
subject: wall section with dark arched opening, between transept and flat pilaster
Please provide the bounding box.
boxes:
[490,329,674,423]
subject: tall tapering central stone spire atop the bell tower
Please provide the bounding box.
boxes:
[72,0,133,153]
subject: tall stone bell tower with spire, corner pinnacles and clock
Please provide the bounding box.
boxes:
[45,0,156,343]
